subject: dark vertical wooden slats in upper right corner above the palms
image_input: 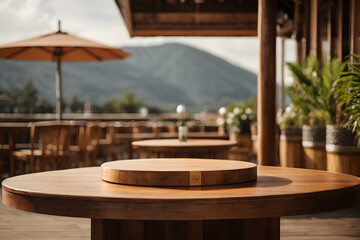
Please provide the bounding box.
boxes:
[293,0,360,63]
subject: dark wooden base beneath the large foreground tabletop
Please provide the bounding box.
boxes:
[91,218,280,240]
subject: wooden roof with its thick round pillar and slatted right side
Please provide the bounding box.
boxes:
[115,0,360,165]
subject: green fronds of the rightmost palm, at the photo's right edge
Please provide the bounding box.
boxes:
[334,55,360,146]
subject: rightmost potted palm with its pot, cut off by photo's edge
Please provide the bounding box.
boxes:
[332,55,360,176]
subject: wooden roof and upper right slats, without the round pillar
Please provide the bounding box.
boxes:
[115,0,360,59]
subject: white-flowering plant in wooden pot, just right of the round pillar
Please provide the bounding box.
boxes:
[278,105,303,167]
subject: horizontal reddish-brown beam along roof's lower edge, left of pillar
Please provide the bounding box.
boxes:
[128,13,257,36]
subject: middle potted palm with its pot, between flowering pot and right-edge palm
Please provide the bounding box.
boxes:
[287,57,344,170]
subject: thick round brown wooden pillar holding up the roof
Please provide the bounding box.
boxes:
[257,0,277,166]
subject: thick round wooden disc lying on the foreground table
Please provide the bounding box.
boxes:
[101,158,257,187]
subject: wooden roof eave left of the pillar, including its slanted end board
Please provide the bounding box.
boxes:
[115,0,257,37]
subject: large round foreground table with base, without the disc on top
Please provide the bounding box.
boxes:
[2,160,360,240]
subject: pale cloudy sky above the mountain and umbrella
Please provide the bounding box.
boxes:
[0,0,295,83]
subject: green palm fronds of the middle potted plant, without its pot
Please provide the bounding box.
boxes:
[286,57,345,125]
